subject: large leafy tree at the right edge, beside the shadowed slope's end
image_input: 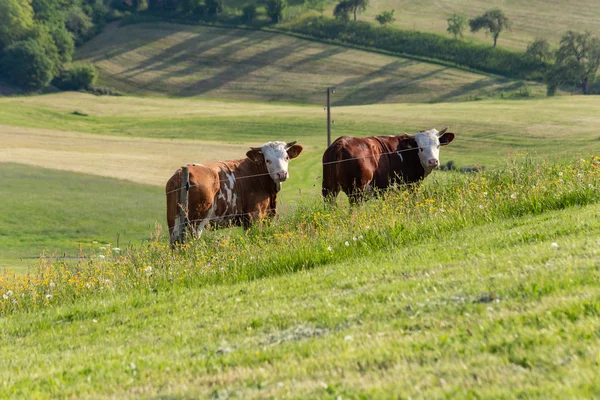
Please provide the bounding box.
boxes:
[547,31,600,95]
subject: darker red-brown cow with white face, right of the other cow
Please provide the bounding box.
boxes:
[323,128,454,203]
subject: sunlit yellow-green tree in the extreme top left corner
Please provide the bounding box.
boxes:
[0,0,33,51]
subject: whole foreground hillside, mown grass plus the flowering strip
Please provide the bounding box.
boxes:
[0,158,600,399]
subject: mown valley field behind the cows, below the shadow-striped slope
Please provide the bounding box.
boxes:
[0,93,600,269]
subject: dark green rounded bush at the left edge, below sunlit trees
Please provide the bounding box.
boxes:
[0,39,56,90]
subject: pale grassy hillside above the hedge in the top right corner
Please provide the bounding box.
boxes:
[362,0,600,50]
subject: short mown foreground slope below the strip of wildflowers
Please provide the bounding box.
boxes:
[0,205,600,399]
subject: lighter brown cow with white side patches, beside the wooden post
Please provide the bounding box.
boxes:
[166,142,302,245]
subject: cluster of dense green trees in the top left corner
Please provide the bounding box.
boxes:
[0,0,109,90]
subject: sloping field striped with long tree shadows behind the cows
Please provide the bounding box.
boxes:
[72,23,543,105]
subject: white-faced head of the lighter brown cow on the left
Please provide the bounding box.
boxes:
[246,142,302,187]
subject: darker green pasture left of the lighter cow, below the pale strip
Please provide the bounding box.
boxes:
[0,163,165,271]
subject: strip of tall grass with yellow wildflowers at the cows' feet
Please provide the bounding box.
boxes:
[0,156,600,315]
